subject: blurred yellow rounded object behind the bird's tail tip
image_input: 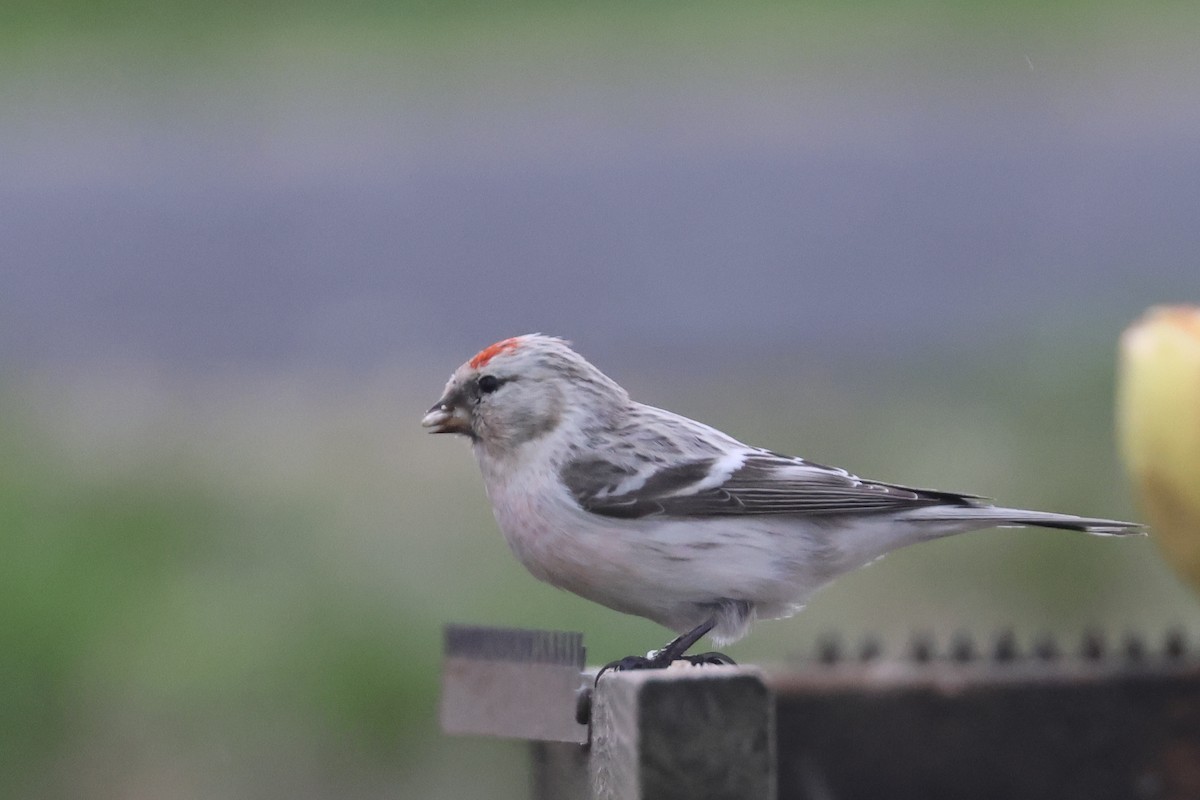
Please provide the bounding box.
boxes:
[1117,306,1200,591]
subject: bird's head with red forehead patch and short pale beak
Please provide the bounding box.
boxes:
[421,333,628,449]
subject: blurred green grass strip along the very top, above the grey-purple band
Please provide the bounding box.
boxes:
[0,0,1180,71]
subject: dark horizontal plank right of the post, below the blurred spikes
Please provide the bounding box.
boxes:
[768,661,1200,800]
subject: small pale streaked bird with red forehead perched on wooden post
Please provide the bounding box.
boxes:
[421,333,1144,669]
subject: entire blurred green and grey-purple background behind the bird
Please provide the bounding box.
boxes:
[0,0,1200,799]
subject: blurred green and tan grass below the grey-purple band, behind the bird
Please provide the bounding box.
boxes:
[0,328,1195,798]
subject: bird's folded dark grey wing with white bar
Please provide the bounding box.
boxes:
[562,449,985,519]
